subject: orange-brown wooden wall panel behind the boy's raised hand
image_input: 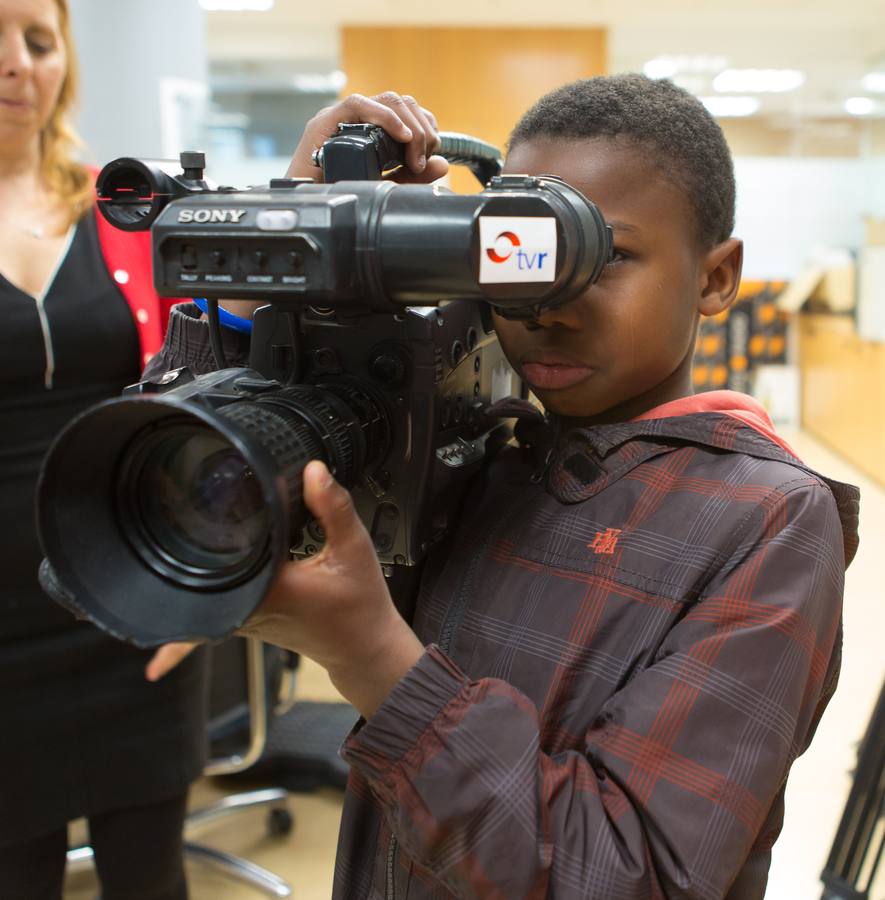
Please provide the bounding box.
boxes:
[341,25,608,192]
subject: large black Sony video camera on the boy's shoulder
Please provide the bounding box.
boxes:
[37,125,611,647]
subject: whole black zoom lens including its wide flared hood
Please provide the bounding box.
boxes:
[37,370,389,647]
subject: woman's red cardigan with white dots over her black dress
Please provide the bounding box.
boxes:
[90,167,187,367]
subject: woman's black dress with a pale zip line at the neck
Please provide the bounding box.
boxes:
[0,214,205,844]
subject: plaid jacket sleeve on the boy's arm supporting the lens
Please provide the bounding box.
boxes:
[342,479,844,900]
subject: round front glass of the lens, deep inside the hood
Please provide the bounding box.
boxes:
[118,425,270,586]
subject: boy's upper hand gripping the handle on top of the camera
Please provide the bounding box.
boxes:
[286,91,449,184]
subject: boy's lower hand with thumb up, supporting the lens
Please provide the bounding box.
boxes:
[238,460,424,717]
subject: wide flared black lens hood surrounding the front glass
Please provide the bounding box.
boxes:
[37,393,291,647]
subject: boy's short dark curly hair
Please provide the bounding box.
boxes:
[509,73,735,248]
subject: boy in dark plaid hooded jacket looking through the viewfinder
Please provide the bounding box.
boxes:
[152,75,857,900]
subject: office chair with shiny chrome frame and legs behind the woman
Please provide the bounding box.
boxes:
[67,638,293,897]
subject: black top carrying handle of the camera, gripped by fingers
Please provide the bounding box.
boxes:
[313,123,504,186]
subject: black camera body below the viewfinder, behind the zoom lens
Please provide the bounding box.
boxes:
[139,303,521,566]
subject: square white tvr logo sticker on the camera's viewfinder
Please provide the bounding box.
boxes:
[479,216,556,284]
